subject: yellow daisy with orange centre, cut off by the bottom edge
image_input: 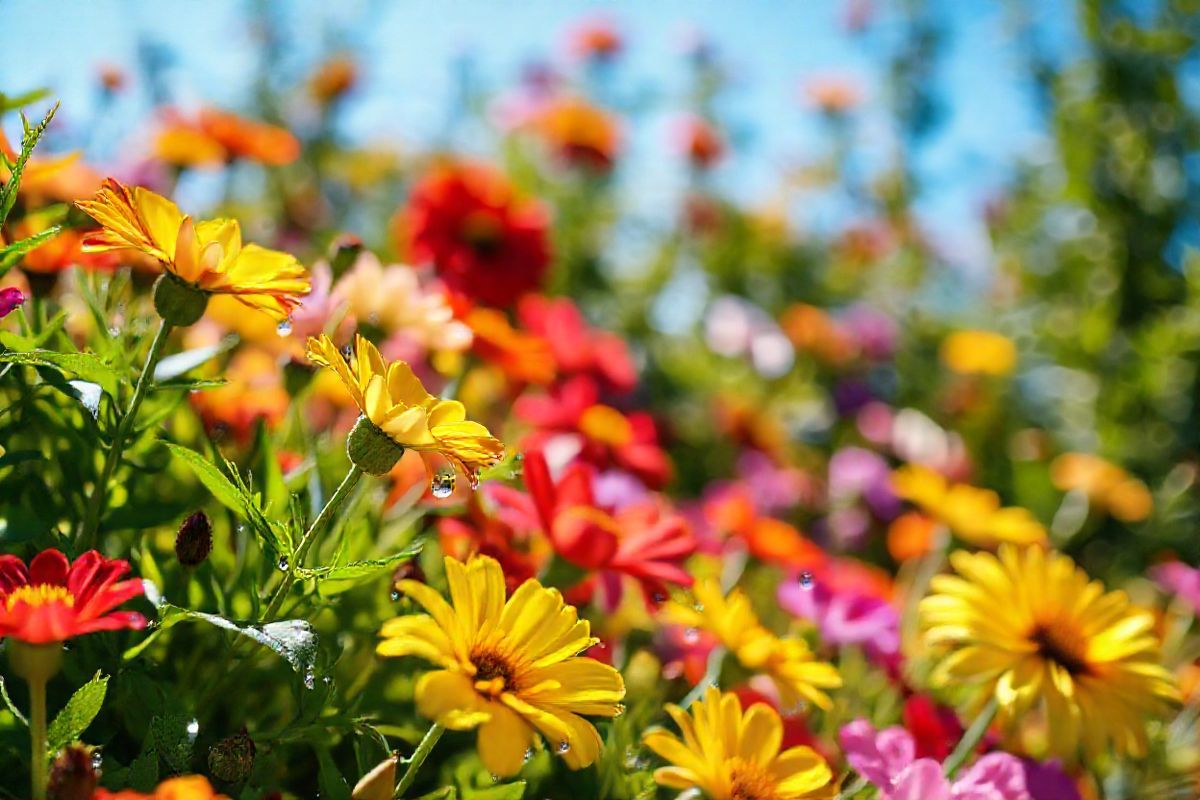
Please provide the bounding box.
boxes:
[643,687,838,800]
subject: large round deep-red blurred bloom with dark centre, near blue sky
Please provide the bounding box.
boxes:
[398,163,550,306]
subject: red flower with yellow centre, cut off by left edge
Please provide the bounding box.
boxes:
[0,549,146,644]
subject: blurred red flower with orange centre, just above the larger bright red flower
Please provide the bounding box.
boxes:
[514,375,671,488]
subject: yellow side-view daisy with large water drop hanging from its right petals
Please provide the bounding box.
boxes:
[307,333,504,479]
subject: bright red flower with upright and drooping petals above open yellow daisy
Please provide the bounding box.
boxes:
[492,450,696,608]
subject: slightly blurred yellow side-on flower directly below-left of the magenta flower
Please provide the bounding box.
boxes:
[662,578,841,709]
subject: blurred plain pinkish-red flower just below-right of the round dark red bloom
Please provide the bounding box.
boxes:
[517,295,637,392]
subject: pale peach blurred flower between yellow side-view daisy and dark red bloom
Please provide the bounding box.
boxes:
[334,252,472,353]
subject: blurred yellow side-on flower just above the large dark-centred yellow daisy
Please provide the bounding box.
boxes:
[892,464,1046,547]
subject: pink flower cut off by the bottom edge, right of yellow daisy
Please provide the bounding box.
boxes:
[840,720,1032,800]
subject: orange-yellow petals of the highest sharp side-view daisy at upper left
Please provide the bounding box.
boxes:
[76,178,308,325]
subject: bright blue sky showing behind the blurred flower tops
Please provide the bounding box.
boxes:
[0,0,1074,267]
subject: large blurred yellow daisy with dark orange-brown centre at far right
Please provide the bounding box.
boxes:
[920,546,1178,758]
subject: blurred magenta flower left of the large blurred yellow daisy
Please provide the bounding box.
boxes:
[779,579,900,662]
